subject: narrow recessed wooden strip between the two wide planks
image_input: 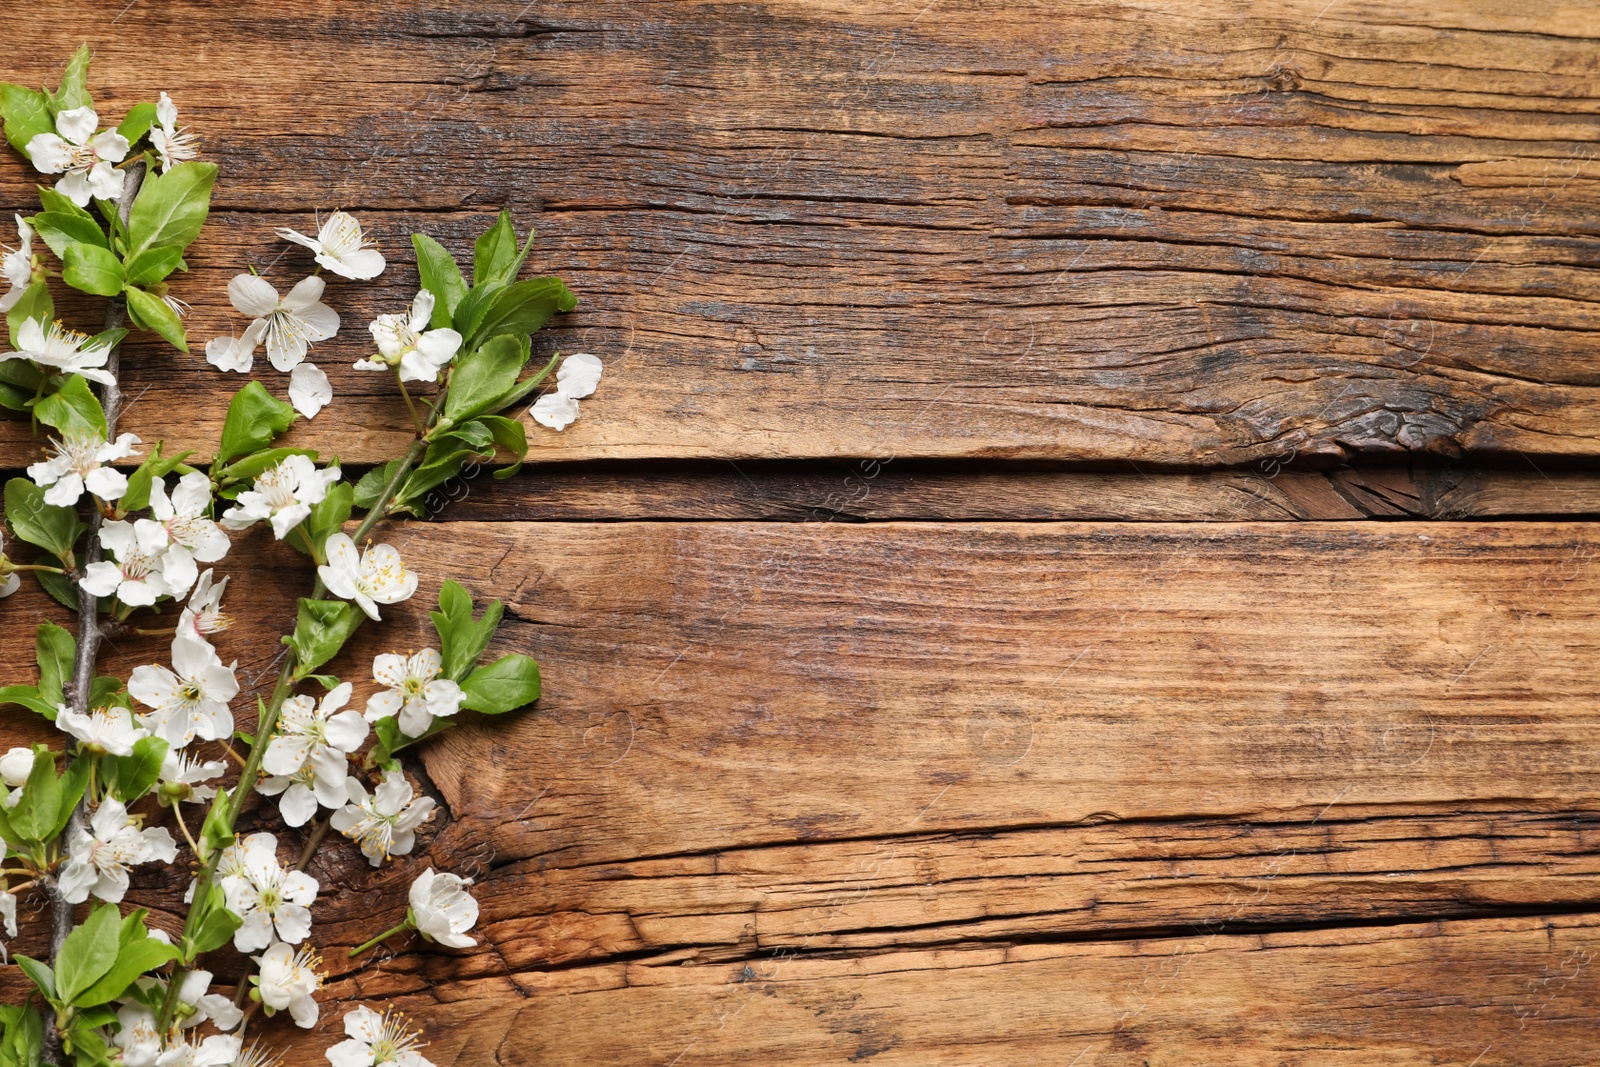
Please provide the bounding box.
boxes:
[435,459,1600,523]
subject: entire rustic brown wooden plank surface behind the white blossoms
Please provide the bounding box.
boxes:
[0,0,1600,1067]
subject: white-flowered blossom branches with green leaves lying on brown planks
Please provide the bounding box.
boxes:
[0,48,572,1067]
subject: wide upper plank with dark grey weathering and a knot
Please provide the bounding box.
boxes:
[0,0,1600,464]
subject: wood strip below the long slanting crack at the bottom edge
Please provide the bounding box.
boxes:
[406,918,1600,1067]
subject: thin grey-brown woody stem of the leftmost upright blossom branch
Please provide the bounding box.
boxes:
[43,160,144,1064]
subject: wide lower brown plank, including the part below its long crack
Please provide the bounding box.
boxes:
[0,522,1600,1065]
